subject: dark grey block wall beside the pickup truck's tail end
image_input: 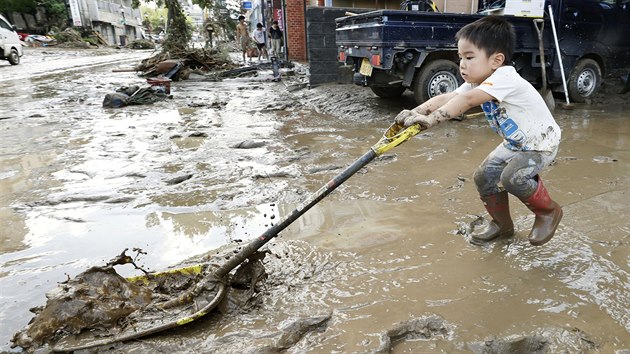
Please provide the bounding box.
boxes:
[306,6,373,86]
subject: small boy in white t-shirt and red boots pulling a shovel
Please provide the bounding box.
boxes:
[396,16,562,246]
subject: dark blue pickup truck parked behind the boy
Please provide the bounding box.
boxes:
[336,0,630,103]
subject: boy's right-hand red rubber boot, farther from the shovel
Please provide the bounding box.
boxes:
[521,176,562,246]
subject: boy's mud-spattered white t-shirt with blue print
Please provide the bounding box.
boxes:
[455,66,561,152]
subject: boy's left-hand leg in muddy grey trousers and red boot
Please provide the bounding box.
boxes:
[471,144,514,245]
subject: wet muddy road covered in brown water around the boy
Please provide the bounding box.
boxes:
[0,50,630,353]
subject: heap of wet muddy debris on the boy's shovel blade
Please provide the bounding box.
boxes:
[13,249,232,352]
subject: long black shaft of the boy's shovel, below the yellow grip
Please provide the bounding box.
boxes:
[215,149,376,278]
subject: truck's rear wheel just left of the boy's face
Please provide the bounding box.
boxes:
[413,59,463,104]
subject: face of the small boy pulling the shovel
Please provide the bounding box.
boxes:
[457,38,505,84]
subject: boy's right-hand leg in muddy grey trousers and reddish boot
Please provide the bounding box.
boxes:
[501,151,562,246]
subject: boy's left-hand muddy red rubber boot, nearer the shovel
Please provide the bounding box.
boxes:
[471,191,514,245]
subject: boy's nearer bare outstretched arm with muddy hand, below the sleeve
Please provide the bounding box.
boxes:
[404,88,494,128]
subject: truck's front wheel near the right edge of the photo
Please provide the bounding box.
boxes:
[567,59,602,103]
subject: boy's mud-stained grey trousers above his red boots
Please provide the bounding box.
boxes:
[474,144,558,199]
